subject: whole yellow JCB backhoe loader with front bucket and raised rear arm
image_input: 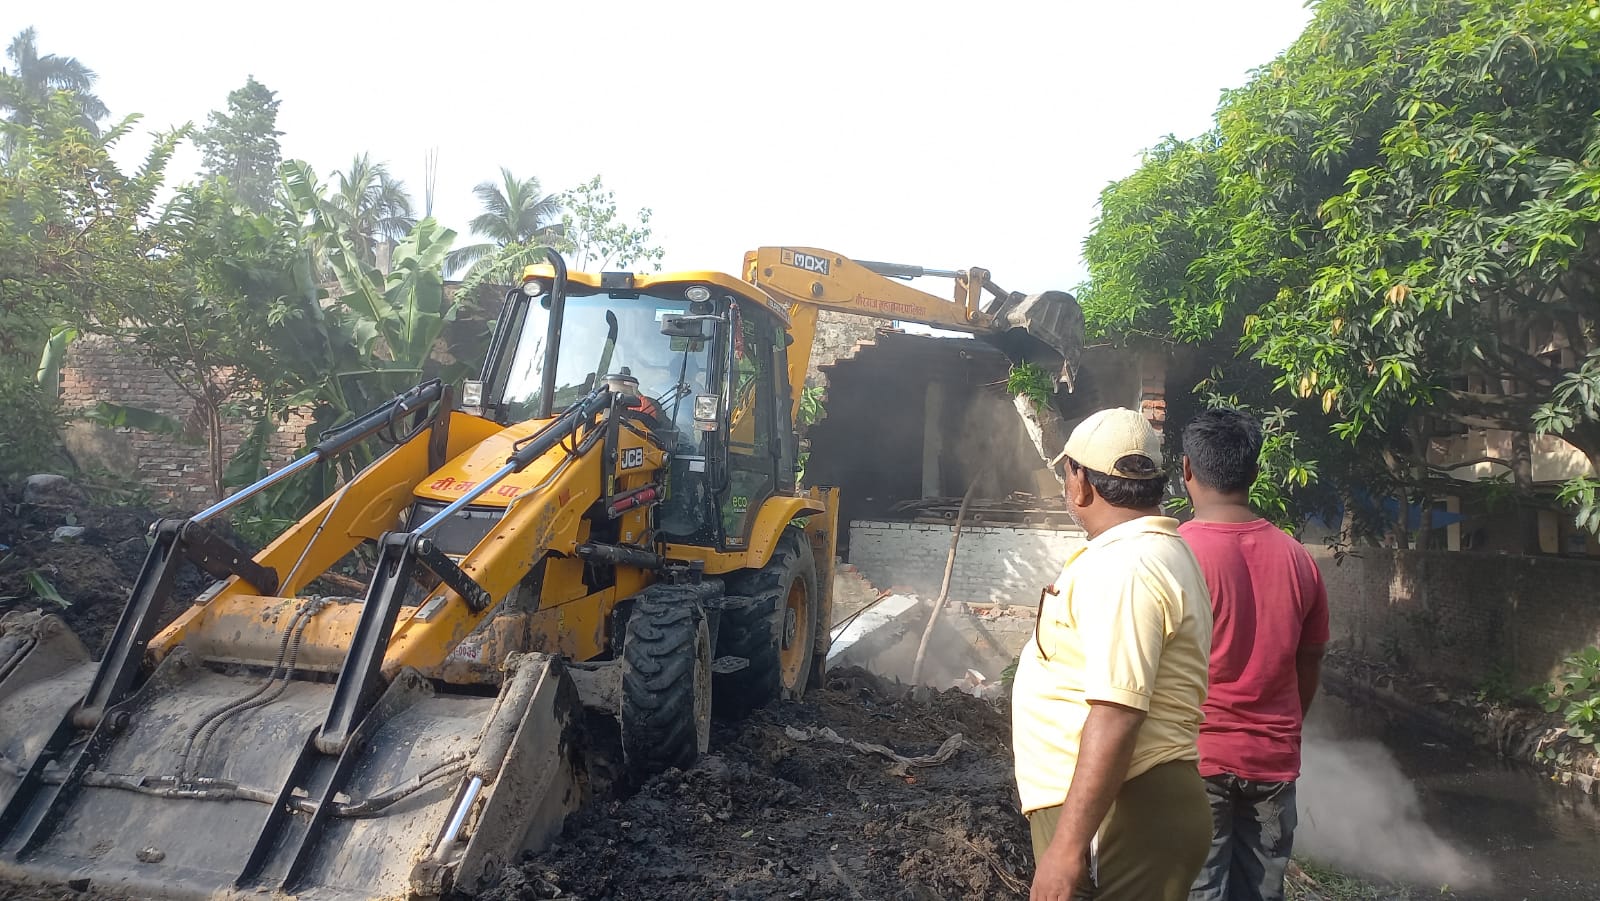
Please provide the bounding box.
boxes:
[0,248,1082,899]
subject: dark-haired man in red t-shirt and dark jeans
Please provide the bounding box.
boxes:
[1178,410,1328,901]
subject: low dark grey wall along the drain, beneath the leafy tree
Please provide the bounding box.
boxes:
[1312,549,1600,687]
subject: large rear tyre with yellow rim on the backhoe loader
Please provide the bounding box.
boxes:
[712,527,819,719]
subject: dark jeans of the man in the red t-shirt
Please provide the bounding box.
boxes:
[1189,773,1296,901]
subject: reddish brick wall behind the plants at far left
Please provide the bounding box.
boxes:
[61,336,307,509]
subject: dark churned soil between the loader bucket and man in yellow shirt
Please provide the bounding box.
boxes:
[480,669,1032,901]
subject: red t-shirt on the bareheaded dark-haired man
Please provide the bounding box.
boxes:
[1178,520,1328,783]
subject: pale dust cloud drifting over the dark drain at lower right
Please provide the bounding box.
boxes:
[1294,726,1490,888]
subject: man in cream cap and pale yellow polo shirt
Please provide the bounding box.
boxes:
[1011,408,1211,901]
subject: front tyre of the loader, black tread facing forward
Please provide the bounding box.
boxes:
[621,592,710,776]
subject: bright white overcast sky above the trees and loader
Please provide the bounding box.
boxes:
[0,0,1310,293]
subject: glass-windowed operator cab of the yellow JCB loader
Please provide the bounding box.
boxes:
[480,266,795,551]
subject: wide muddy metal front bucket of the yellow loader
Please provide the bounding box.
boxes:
[0,618,586,901]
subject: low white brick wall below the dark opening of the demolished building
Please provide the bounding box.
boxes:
[850,522,1085,608]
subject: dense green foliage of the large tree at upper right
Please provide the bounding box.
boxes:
[1080,0,1600,534]
